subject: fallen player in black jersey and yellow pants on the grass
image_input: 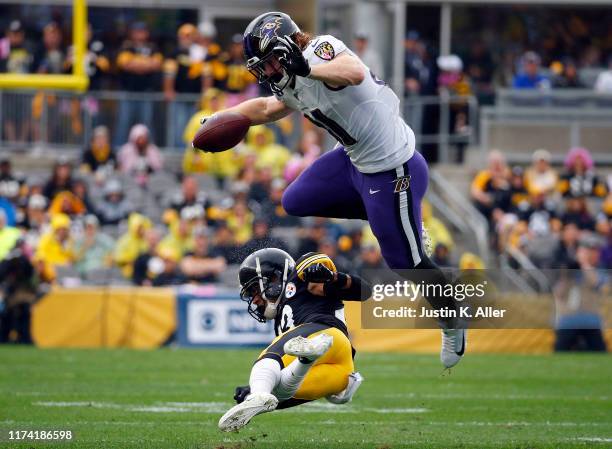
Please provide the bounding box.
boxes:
[219,248,372,432]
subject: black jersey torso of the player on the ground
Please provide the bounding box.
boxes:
[274,273,348,336]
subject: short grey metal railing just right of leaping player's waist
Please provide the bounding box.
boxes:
[404,91,479,163]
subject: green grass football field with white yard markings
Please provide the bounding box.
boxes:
[0,347,612,449]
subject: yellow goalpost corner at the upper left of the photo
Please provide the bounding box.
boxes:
[0,0,89,91]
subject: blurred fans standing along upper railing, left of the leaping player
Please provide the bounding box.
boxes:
[0,20,257,147]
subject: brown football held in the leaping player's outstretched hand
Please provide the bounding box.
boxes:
[193,112,251,153]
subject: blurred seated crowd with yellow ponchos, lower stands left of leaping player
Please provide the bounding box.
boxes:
[0,119,402,286]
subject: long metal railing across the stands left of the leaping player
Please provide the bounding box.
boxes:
[0,90,306,150]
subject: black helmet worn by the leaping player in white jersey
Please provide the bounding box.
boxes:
[243,12,300,95]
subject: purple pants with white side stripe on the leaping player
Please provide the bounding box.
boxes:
[283,148,428,269]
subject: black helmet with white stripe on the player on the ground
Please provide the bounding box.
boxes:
[238,248,295,323]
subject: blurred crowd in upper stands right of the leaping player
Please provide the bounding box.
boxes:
[405,7,612,103]
